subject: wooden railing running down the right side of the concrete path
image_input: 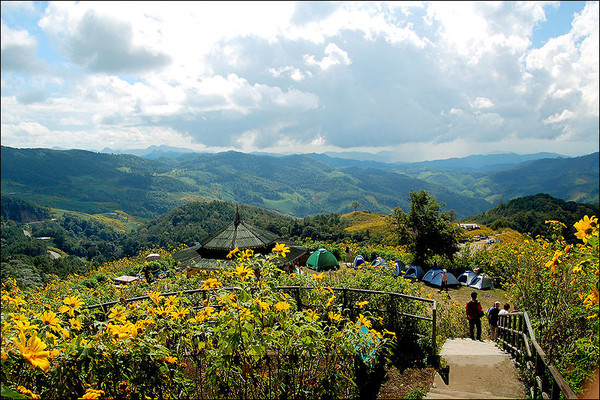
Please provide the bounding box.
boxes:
[498,312,577,400]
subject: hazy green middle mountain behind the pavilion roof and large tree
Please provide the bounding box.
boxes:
[170,152,490,216]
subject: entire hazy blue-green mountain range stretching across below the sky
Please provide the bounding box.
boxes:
[1,146,599,222]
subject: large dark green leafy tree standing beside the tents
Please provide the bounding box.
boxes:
[388,190,460,264]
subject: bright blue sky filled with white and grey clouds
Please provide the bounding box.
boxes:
[0,1,599,162]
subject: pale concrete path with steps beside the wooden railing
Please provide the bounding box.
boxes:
[425,339,525,399]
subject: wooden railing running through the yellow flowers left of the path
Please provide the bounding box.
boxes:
[85,286,437,348]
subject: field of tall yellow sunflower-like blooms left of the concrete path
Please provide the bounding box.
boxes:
[1,245,427,399]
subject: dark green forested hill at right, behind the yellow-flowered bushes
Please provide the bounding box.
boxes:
[469,194,600,238]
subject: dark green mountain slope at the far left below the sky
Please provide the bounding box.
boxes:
[0,146,188,217]
